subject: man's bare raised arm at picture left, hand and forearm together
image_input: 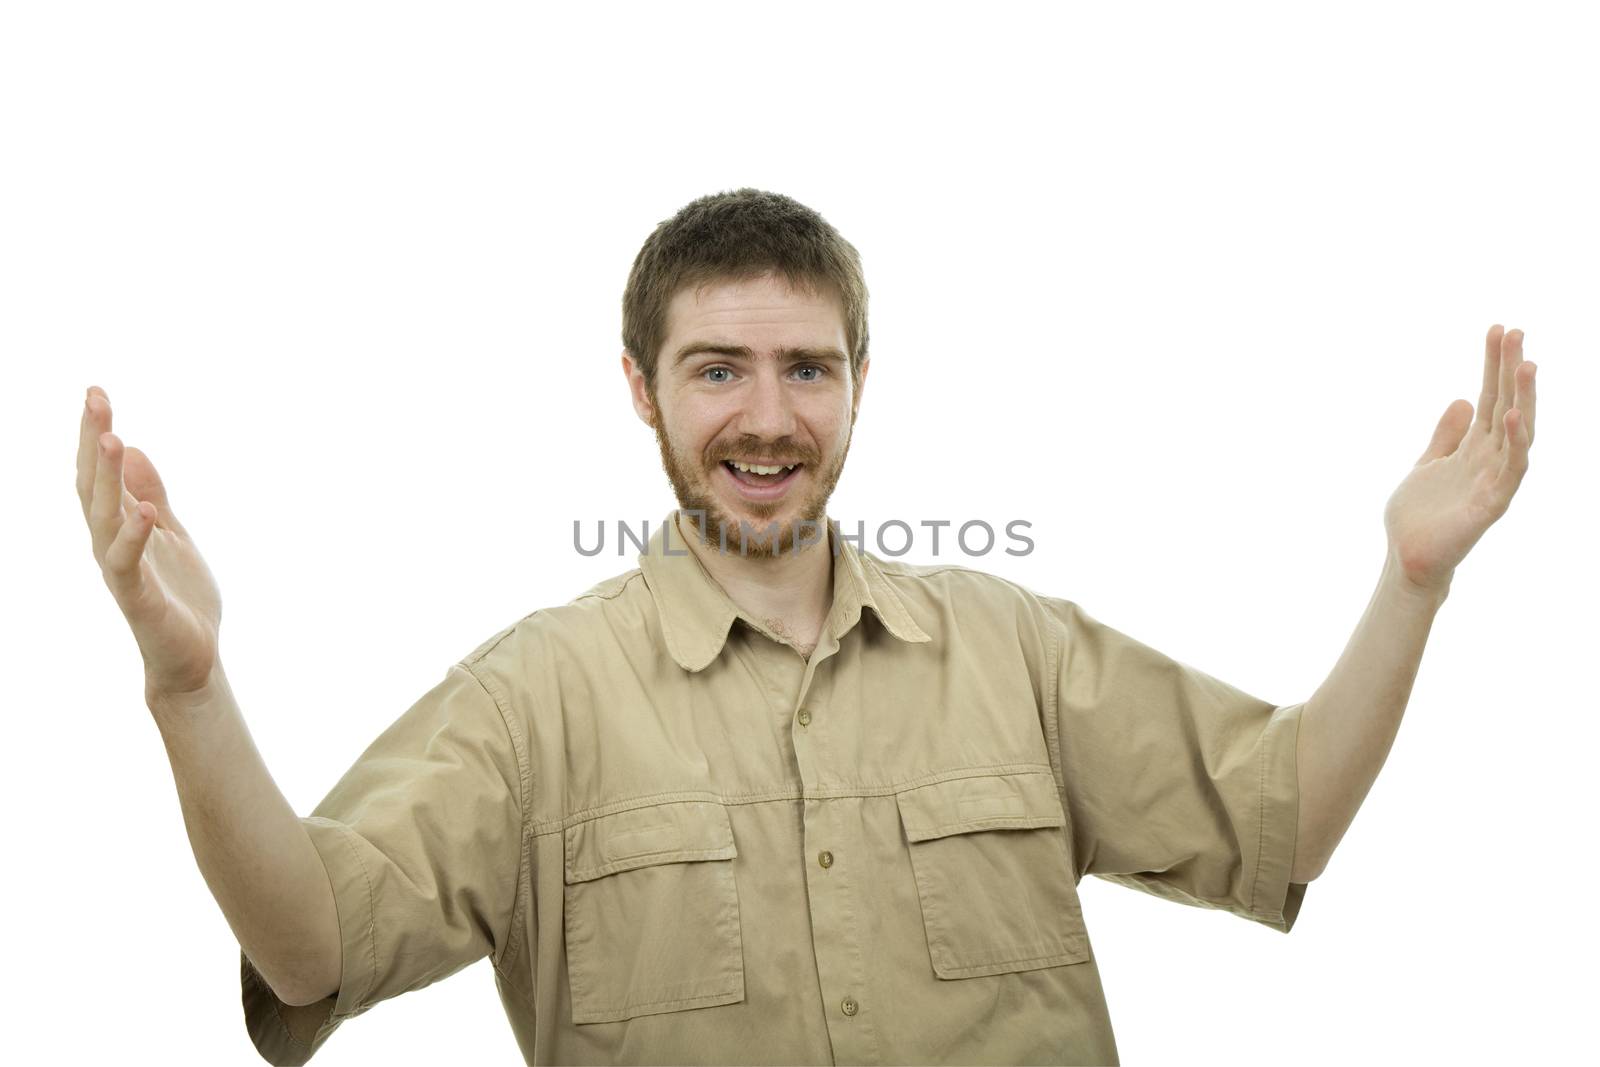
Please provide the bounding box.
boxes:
[77,386,342,1005]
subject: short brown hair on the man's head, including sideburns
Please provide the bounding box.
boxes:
[622,187,867,392]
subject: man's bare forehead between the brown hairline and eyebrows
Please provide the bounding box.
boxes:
[667,274,845,347]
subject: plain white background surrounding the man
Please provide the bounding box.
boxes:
[0,3,1600,1067]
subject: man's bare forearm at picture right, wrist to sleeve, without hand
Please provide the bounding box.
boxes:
[1290,560,1448,881]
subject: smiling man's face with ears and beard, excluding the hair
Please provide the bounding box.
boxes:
[622,275,866,557]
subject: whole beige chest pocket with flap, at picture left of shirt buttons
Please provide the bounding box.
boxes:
[565,801,744,1024]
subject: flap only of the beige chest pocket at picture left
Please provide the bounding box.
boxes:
[566,800,739,885]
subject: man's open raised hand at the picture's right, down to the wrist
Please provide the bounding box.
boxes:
[1384,325,1536,593]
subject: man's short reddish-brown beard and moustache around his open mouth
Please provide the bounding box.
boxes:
[651,416,856,560]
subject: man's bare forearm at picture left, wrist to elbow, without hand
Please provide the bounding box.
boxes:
[147,664,342,1005]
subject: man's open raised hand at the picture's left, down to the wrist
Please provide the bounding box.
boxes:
[78,386,222,707]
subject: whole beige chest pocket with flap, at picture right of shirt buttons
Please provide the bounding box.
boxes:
[894,771,1090,979]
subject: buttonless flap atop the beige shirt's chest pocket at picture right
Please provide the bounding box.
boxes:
[894,773,1067,841]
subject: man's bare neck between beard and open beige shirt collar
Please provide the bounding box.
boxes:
[678,517,834,656]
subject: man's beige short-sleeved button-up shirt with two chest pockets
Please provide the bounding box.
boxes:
[242,518,1306,1064]
